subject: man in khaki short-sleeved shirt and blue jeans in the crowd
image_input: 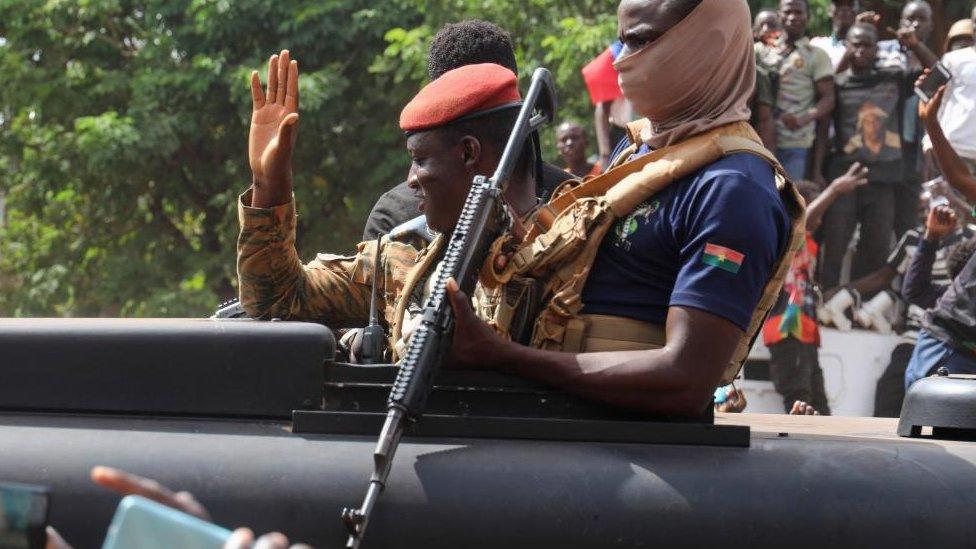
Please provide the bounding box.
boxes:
[756,0,834,181]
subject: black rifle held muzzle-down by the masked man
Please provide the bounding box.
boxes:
[342,68,556,548]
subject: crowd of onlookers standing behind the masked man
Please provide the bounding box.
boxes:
[557,0,976,417]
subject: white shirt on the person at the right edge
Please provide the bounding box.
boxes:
[925,48,976,161]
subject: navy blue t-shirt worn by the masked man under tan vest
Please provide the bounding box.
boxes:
[582,142,790,331]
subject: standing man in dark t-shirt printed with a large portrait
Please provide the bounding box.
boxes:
[816,23,936,288]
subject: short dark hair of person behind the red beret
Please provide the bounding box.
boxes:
[427,21,518,80]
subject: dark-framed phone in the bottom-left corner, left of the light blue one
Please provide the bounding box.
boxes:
[0,482,50,549]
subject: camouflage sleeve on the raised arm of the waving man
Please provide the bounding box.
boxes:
[237,191,386,328]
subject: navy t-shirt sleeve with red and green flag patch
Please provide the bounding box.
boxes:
[669,162,789,331]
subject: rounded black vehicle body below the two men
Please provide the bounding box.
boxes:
[0,414,976,549]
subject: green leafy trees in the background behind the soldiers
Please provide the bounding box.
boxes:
[0,0,969,316]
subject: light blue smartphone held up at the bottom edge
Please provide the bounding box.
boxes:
[102,496,231,549]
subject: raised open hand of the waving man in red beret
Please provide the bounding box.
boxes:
[247,50,298,208]
